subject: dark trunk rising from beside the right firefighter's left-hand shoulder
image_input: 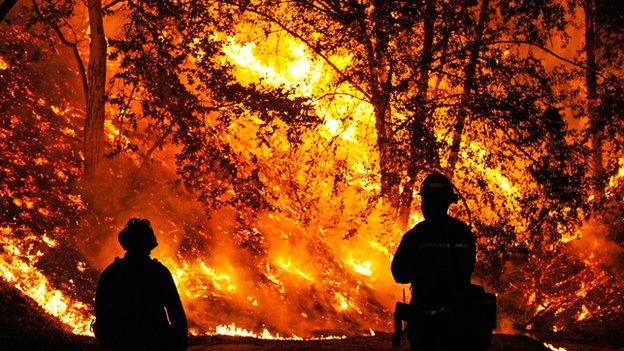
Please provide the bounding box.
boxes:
[398,1,437,229]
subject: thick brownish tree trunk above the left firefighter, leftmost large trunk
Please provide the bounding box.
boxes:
[84,0,106,180]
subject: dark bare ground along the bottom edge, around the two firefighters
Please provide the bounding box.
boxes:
[0,280,624,351]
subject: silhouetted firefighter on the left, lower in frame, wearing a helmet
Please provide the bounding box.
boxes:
[93,218,188,351]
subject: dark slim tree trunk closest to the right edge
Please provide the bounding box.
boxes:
[583,0,603,191]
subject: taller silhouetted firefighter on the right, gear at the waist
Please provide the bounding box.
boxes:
[391,172,479,351]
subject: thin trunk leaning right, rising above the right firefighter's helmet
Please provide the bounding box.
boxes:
[447,0,490,178]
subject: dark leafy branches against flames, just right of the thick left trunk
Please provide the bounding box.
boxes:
[110,1,319,214]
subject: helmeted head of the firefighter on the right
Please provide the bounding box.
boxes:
[420,172,459,218]
